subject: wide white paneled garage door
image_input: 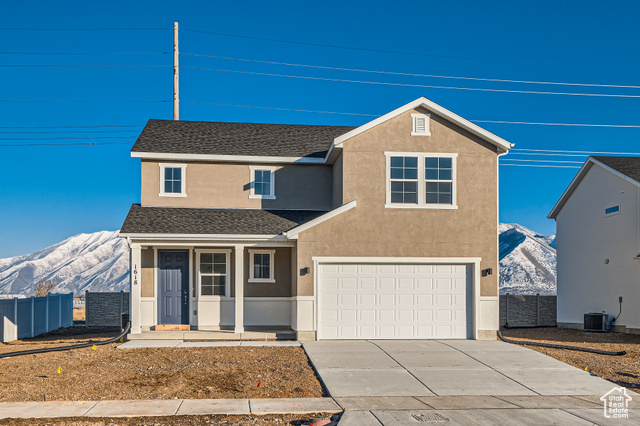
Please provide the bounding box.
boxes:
[318,264,471,339]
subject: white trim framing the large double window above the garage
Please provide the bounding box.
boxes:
[384,152,458,210]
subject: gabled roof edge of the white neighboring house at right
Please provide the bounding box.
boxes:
[547,156,640,219]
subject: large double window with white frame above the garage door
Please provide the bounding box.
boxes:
[385,152,458,209]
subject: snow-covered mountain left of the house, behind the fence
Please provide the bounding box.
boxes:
[0,231,129,296]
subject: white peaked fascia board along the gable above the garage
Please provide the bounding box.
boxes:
[331,96,514,151]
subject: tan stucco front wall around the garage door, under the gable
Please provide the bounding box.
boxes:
[297,110,498,296]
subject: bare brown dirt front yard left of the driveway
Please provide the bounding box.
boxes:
[0,327,323,401]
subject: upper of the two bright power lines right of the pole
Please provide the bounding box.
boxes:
[180,53,640,89]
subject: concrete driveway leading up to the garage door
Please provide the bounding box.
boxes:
[303,340,640,426]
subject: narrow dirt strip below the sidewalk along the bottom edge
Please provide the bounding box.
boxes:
[0,413,340,426]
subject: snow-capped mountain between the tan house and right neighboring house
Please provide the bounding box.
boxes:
[498,223,556,294]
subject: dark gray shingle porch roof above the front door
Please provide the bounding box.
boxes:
[120,204,326,235]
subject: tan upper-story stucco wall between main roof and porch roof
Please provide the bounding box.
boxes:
[141,161,333,210]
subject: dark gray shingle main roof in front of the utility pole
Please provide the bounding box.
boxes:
[131,120,355,158]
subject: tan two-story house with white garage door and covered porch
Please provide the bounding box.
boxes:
[120,98,512,339]
